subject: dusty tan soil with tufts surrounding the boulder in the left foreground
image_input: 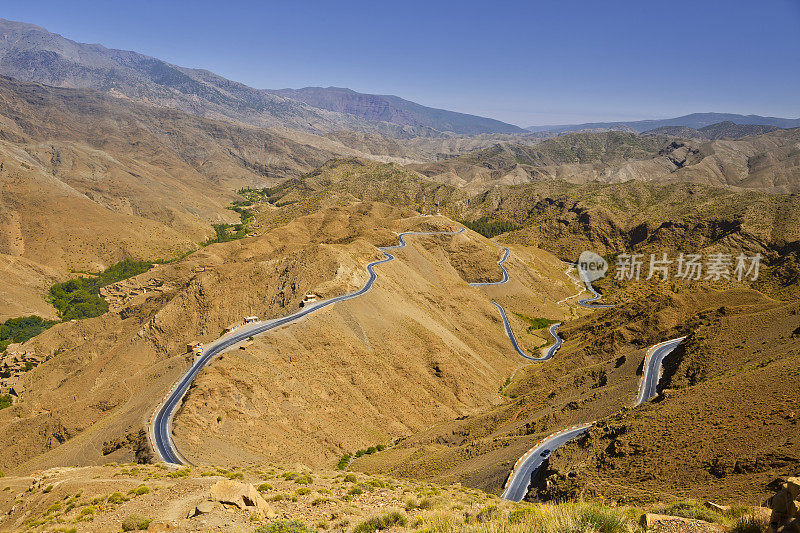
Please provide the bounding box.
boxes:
[0,464,497,533]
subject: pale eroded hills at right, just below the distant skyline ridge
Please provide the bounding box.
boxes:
[414,129,800,193]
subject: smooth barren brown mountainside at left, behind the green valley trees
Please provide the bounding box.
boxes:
[0,78,428,319]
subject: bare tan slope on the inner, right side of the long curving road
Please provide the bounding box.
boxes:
[174,214,572,467]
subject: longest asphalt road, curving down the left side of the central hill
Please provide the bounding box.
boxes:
[150,228,466,465]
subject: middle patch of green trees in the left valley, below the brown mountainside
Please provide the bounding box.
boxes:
[50,259,153,322]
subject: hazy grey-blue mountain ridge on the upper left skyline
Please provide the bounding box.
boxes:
[0,19,524,138]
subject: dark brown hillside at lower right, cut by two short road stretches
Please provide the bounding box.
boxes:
[353,284,800,504]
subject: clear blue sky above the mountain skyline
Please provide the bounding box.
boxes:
[0,0,800,126]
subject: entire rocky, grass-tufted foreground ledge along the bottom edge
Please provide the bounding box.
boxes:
[0,464,780,533]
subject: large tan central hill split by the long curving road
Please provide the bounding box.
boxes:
[0,204,572,471]
